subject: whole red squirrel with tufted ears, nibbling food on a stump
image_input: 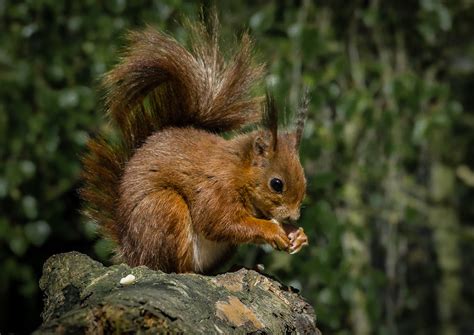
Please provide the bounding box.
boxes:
[80,18,308,273]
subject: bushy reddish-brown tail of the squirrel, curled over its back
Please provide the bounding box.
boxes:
[80,18,263,241]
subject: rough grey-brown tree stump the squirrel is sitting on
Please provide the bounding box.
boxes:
[35,252,319,334]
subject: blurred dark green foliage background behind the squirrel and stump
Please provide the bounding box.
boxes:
[0,0,474,334]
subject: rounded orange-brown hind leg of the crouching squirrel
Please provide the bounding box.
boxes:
[120,189,193,273]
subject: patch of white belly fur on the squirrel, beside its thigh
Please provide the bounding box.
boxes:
[193,235,230,272]
